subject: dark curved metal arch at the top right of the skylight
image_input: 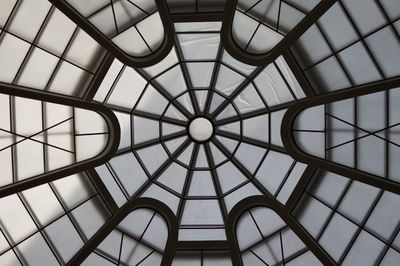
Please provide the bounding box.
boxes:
[221,0,337,66]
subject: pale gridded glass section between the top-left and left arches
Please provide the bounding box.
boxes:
[0,0,104,96]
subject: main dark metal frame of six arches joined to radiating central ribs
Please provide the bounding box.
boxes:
[0,0,400,265]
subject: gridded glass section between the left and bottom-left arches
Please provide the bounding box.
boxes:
[0,173,109,265]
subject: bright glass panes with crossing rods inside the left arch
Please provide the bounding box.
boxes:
[0,94,109,187]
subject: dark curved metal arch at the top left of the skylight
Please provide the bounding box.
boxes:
[49,0,174,67]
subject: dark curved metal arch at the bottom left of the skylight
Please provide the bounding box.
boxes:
[67,198,178,266]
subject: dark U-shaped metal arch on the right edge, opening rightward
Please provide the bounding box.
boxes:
[281,77,400,194]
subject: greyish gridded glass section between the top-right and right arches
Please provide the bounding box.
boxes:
[292,0,400,94]
